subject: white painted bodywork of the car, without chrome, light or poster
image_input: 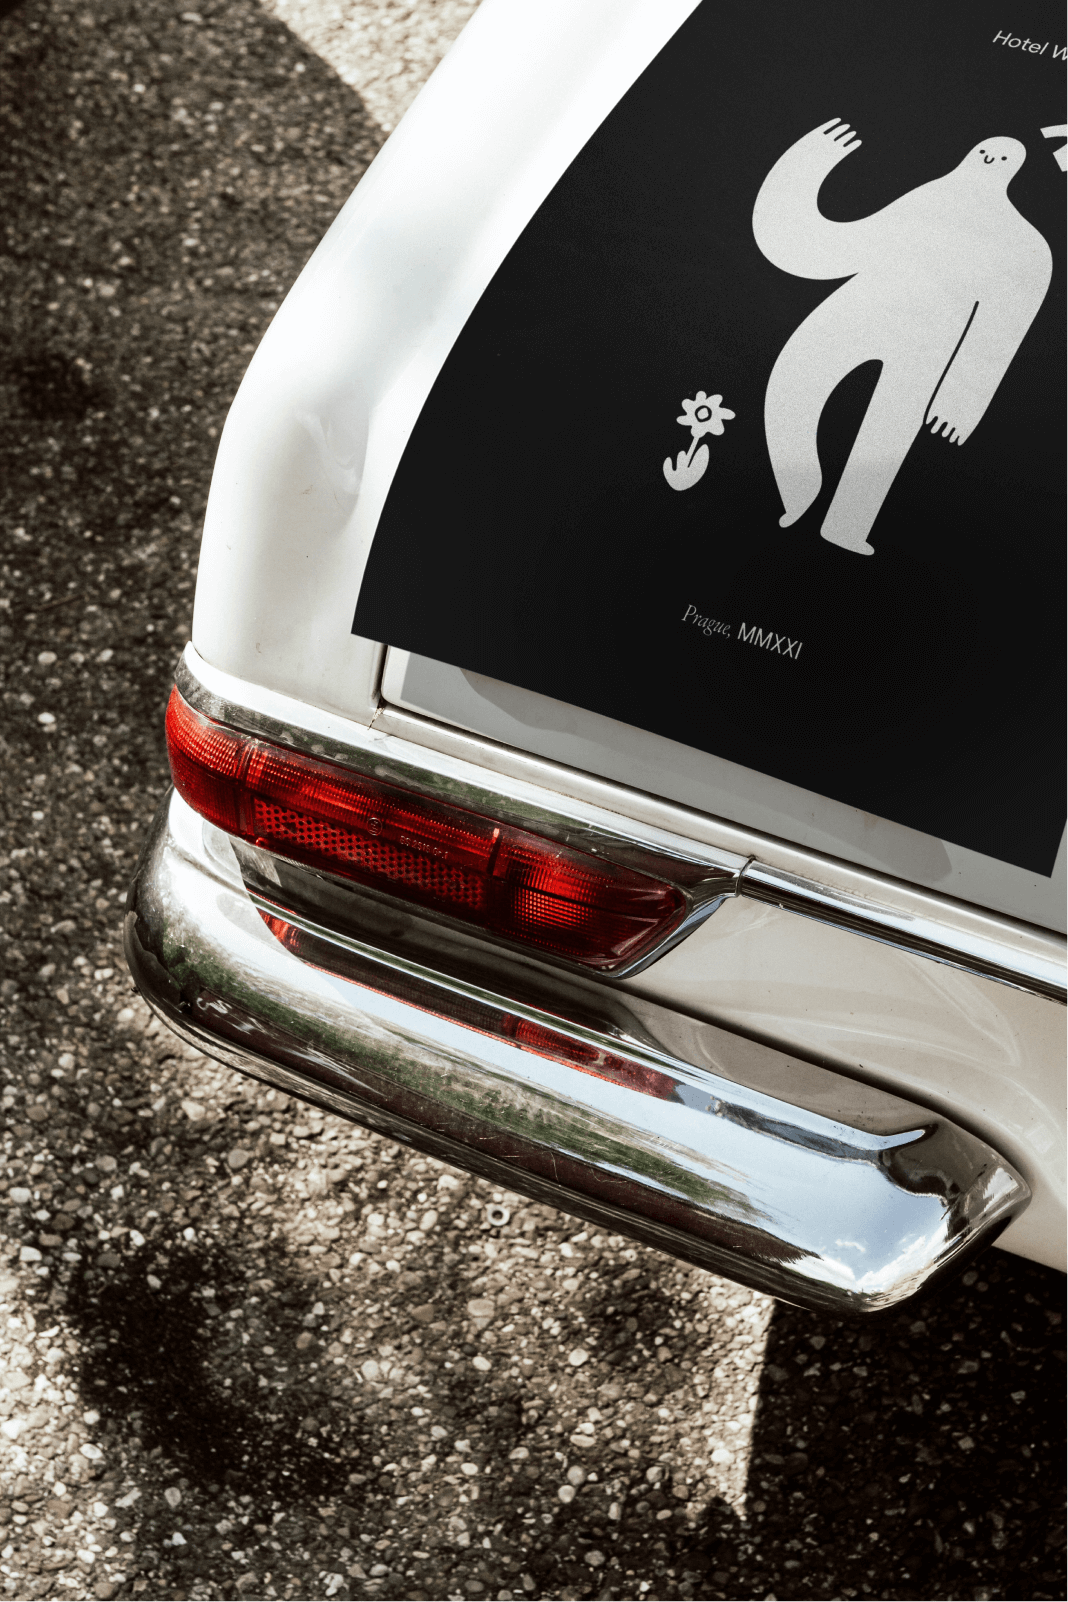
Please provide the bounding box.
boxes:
[191,0,1068,1267]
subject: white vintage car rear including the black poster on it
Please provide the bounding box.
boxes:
[126,0,1066,1312]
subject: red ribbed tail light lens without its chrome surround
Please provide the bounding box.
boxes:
[167,690,685,969]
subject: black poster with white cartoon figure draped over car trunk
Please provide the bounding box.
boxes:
[354,0,1068,875]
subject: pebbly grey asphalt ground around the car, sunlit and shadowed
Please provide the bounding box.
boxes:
[0,0,1065,1602]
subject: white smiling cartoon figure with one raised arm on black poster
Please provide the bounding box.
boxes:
[753,117,1052,556]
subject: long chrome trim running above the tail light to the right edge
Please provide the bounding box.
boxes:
[176,646,1068,1004]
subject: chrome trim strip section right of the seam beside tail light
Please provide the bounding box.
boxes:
[738,862,1068,1006]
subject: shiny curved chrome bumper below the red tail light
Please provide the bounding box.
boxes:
[126,793,1030,1312]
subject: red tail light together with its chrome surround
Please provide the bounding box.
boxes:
[167,650,746,979]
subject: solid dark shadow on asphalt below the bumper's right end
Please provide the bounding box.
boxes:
[739,1250,1065,1602]
